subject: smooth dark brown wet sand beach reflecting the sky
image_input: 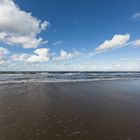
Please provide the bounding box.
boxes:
[0,80,140,140]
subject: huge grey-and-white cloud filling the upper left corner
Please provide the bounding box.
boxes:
[0,0,49,48]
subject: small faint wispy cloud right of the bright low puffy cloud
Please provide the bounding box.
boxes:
[56,50,81,60]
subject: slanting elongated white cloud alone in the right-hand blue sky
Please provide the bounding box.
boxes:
[96,34,130,51]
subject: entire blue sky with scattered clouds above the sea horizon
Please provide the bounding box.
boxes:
[0,0,140,71]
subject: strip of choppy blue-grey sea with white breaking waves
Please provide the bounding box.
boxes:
[0,72,140,83]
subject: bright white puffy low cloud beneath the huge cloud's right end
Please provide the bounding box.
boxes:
[25,48,50,63]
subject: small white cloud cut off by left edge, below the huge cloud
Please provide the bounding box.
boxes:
[0,47,10,65]
